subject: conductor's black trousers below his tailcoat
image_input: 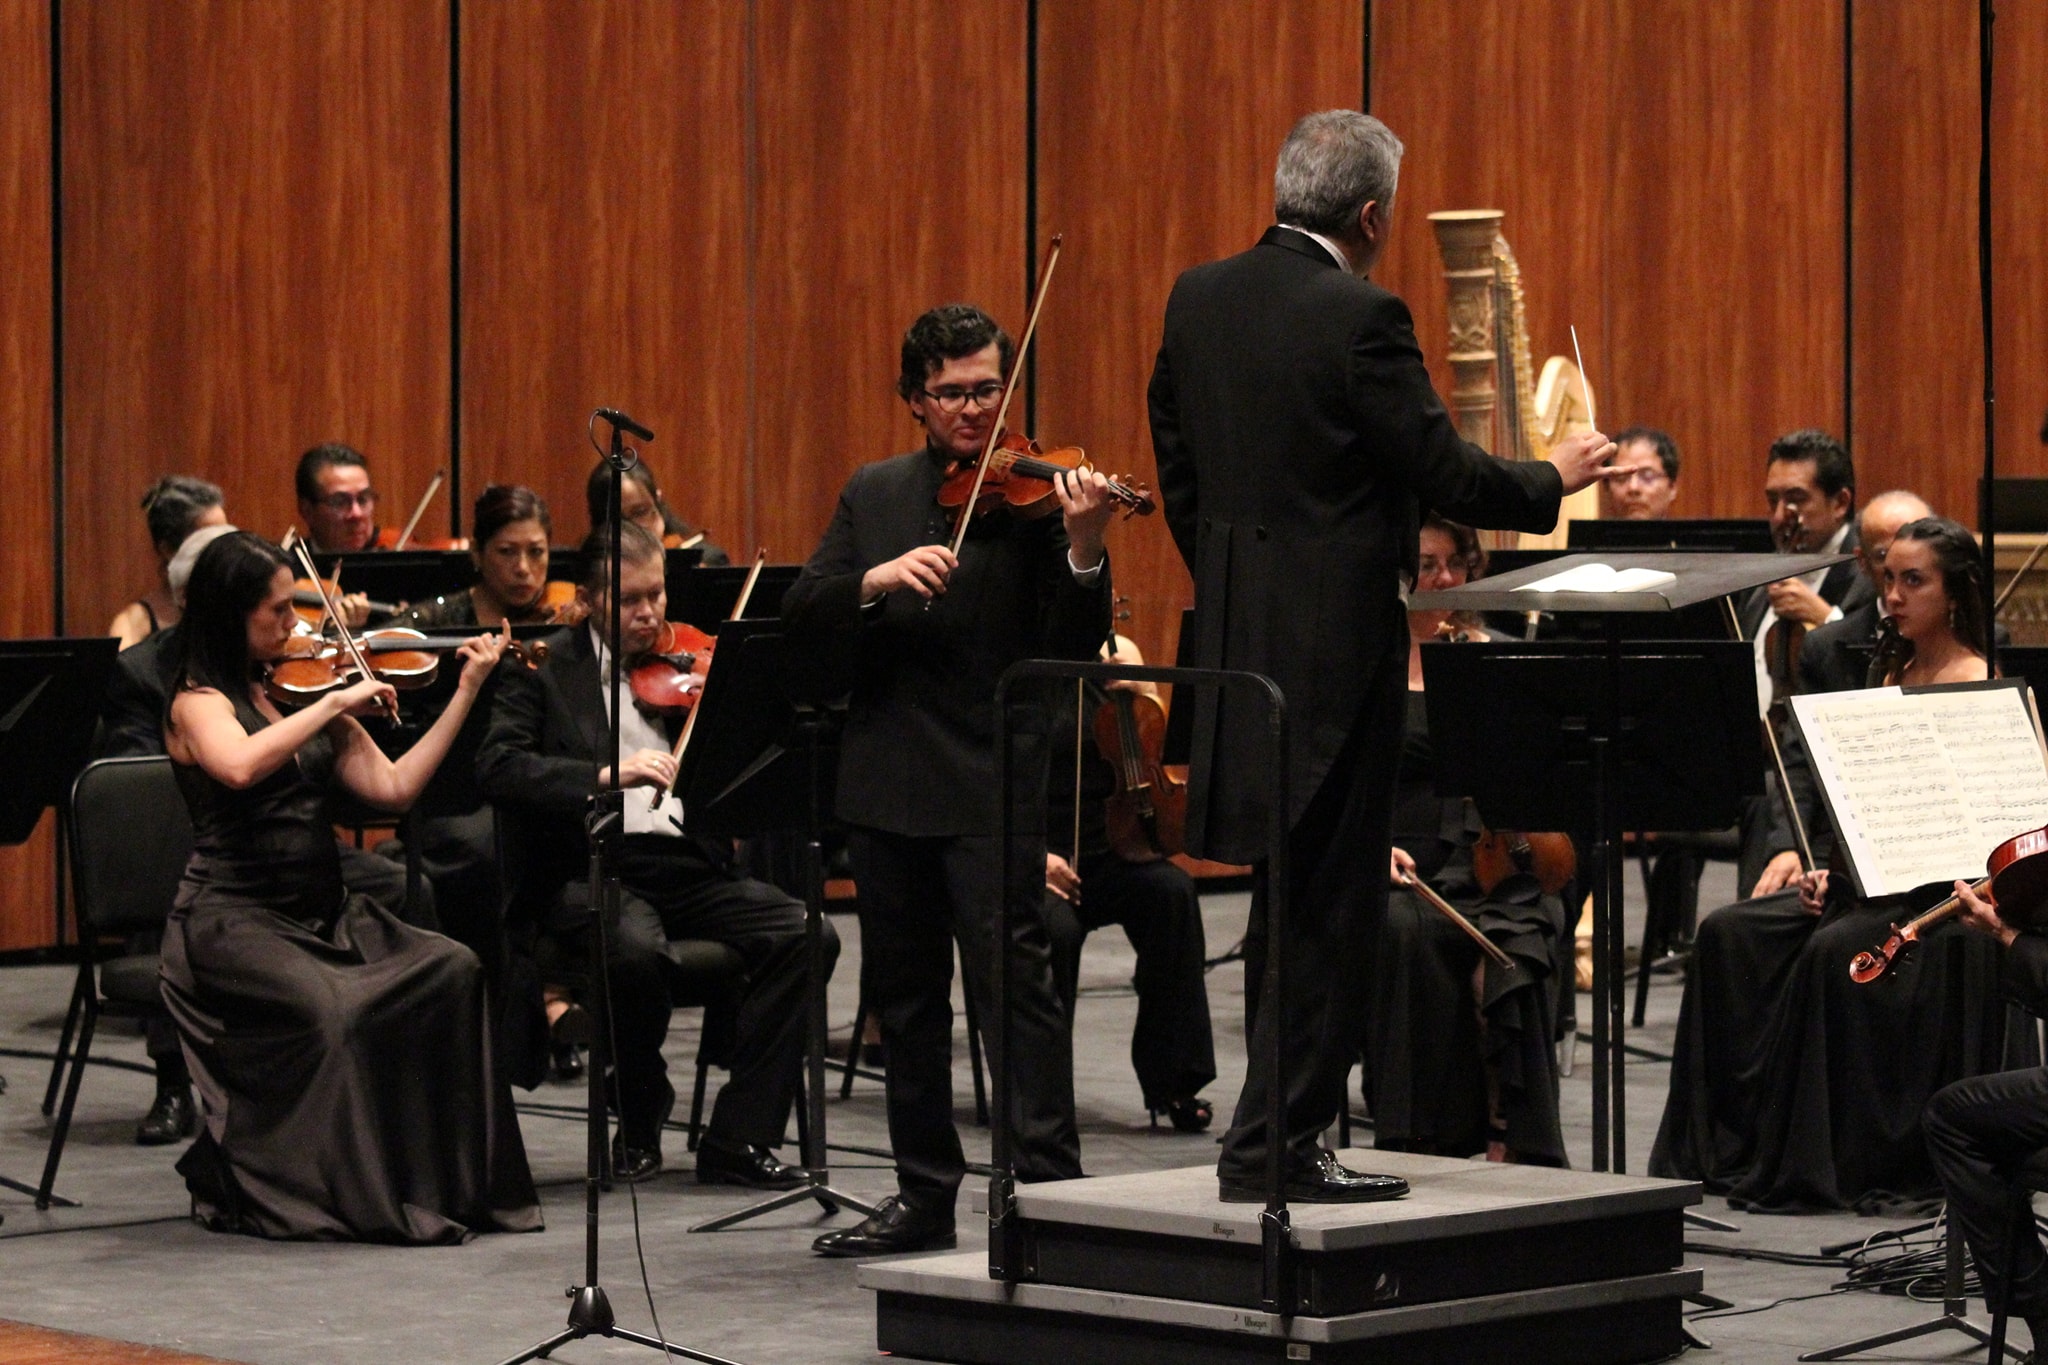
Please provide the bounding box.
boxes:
[1217,630,1407,1181]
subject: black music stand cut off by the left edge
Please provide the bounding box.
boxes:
[0,636,117,1205]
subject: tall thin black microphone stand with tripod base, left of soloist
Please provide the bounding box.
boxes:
[502,409,735,1365]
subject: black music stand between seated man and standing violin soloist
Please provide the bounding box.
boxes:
[676,618,874,1232]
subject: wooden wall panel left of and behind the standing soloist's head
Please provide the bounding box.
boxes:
[735,0,1026,561]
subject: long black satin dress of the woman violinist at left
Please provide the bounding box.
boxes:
[162,698,541,1244]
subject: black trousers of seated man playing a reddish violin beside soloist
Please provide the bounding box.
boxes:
[565,835,823,1146]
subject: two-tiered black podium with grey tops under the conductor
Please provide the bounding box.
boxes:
[860,1150,1700,1365]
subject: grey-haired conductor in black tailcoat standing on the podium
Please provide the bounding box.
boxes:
[1147,111,1618,1203]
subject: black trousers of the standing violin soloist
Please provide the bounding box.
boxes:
[846,825,1081,1212]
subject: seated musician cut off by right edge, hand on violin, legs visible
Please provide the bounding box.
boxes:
[1923,882,2048,1359]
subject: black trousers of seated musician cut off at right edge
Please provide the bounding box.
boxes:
[1921,1066,2048,1322]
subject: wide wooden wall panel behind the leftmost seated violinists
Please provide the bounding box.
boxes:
[61,0,451,630]
